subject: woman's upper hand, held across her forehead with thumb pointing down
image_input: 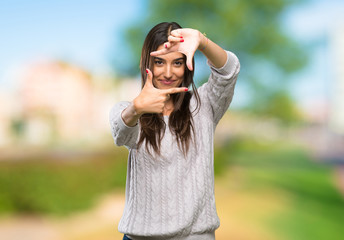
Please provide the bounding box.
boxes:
[150,28,204,71]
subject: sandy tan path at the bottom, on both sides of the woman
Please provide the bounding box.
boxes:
[0,168,286,240]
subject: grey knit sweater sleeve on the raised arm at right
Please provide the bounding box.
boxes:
[198,51,240,125]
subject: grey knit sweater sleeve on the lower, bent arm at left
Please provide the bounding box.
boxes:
[109,102,139,148]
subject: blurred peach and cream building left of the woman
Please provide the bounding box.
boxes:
[0,61,140,148]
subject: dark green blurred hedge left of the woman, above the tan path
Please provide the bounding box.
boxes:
[0,148,127,214]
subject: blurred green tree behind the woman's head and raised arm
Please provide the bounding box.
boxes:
[112,0,307,123]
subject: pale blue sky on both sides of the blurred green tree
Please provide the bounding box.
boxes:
[0,0,344,108]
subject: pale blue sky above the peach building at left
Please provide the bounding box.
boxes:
[0,0,144,86]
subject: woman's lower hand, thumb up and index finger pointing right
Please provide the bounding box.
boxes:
[133,69,188,115]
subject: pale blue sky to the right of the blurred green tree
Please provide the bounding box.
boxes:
[285,0,344,108]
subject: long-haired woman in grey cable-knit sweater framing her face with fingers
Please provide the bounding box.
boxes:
[110,22,240,240]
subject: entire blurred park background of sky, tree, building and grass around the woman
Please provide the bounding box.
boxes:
[0,0,344,240]
